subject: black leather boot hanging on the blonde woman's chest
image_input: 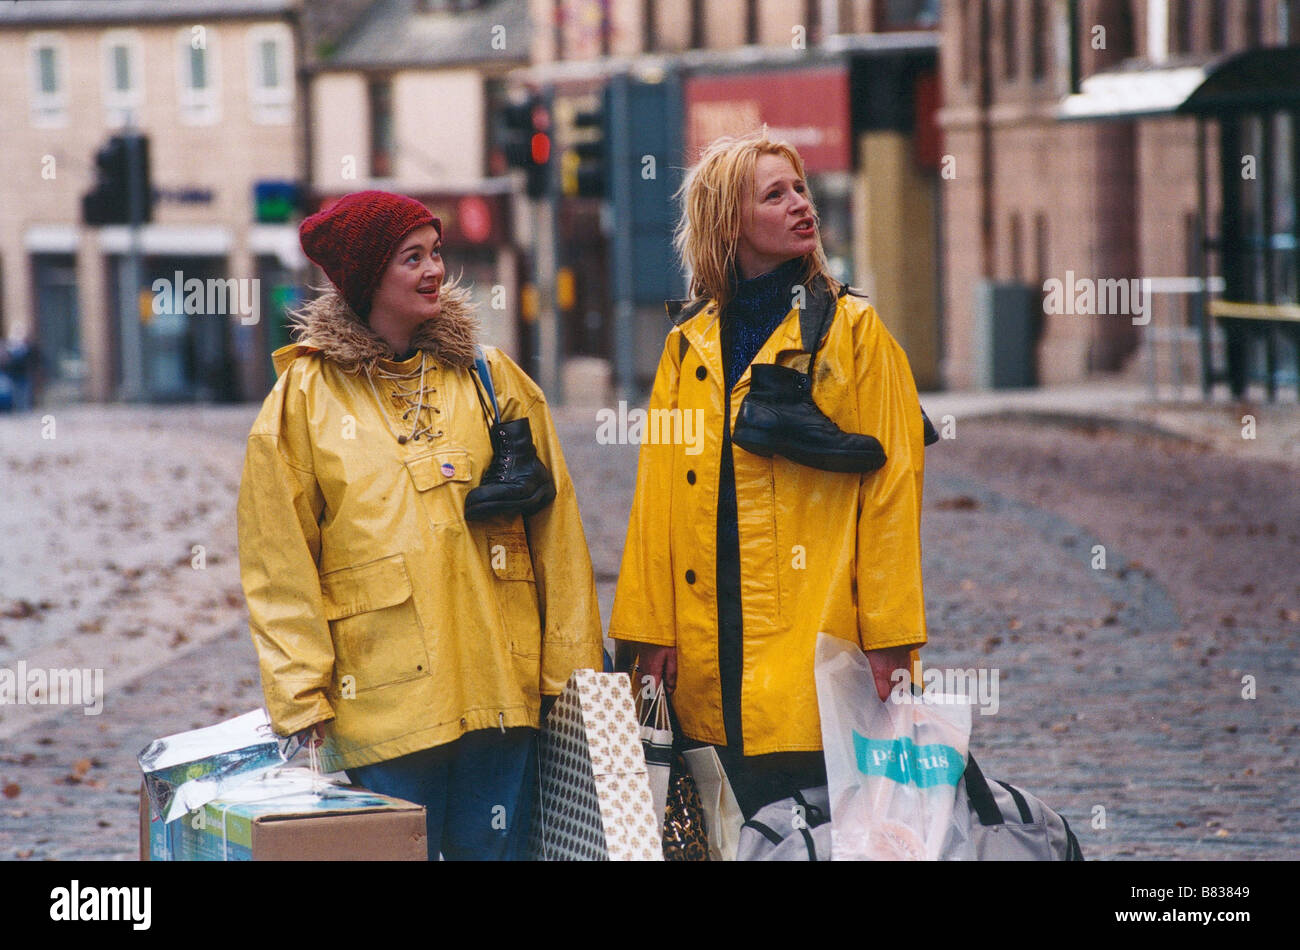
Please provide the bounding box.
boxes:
[732,363,885,474]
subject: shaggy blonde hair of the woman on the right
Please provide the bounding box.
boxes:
[673,126,839,314]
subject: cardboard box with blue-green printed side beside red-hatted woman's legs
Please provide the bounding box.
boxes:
[140,769,429,860]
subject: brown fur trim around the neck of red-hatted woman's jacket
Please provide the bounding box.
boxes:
[290,281,480,373]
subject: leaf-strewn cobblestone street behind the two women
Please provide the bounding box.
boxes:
[0,407,1300,860]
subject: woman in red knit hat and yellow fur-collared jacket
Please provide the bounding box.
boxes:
[239,191,602,859]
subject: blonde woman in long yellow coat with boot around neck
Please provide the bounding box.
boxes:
[610,130,926,817]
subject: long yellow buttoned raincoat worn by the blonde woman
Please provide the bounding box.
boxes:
[610,282,926,755]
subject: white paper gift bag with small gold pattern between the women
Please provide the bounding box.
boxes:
[529,669,663,860]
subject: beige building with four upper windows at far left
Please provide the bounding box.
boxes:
[0,0,312,402]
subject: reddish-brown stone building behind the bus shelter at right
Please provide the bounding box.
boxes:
[940,0,1300,387]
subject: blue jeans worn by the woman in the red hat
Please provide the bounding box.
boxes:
[347,726,537,860]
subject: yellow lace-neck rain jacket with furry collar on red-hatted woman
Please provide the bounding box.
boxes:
[238,292,602,769]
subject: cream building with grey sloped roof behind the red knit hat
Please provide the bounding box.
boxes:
[309,0,532,359]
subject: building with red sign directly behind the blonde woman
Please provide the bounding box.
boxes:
[520,0,943,389]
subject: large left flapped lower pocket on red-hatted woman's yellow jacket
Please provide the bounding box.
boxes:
[321,554,429,697]
